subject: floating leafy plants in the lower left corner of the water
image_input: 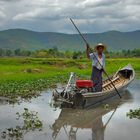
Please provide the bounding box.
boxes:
[1,108,43,140]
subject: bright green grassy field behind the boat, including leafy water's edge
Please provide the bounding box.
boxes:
[0,58,140,98]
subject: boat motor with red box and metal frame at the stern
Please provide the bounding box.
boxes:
[53,72,94,106]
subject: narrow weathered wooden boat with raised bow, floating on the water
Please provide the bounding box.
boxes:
[53,64,135,107]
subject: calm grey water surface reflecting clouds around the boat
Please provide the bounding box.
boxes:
[0,80,140,140]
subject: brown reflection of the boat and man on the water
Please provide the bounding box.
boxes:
[51,91,132,140]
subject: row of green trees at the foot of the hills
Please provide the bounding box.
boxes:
[0,47,140,59]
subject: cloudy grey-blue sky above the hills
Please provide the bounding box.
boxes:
[0,0,140,33]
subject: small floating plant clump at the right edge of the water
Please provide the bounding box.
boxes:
[126,108,140,119]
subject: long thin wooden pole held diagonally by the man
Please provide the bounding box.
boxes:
[70,18,121,98]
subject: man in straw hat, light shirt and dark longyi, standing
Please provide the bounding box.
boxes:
[86,43,106,92]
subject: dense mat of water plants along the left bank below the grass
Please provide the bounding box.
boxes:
[0,76,66,101]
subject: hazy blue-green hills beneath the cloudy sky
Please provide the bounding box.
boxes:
[0,29,140,51]
